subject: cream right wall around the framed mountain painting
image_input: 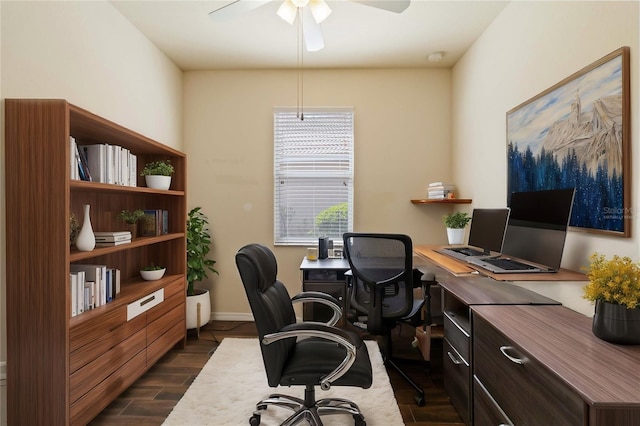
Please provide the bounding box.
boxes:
[452,1,640,314]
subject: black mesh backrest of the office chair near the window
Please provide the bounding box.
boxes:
[343,233,413,333]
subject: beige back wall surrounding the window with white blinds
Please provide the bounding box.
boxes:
[183,70,451,318]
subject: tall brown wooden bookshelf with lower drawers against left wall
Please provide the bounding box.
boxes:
[5,99,187,425]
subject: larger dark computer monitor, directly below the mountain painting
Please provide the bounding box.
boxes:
[502,188,575,269]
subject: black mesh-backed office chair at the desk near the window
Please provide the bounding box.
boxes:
[343,232,433,406]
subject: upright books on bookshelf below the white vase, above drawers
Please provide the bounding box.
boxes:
[69,264,120,317]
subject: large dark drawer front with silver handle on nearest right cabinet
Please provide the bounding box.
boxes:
[473,315,587,426]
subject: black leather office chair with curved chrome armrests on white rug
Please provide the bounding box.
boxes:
[236,244,373,426]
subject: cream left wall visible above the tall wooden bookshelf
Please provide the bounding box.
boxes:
[0,1,182,424]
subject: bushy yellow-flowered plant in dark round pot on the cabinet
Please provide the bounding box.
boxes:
[583,253,640,345]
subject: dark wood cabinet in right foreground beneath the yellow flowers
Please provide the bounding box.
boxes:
[472,306,640,426]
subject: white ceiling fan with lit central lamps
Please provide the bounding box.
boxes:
[209,0,411,52]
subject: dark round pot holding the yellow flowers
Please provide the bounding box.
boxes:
[592,300,640,345]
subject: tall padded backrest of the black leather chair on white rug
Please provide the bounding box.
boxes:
[236,244,296,387]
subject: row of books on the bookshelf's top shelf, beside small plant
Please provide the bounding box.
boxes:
[70,140,137,186]
